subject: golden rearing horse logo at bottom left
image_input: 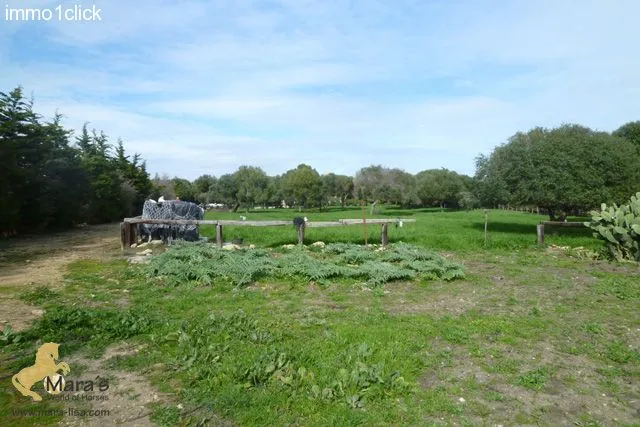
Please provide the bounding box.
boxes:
[11,342,71,402]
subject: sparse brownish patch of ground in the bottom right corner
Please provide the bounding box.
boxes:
[419,342,640,426]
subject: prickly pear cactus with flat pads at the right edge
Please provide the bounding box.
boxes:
[584,193,640,261]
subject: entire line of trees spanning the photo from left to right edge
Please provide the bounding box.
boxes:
[0,87,640,236]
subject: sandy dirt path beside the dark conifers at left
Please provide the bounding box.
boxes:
[0,224,120,331]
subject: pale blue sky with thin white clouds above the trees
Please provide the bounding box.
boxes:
[0,0,640,179]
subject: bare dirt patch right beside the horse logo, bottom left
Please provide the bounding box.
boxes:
[60,344,172,426]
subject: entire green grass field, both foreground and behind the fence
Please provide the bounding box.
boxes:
[0,209,640,426]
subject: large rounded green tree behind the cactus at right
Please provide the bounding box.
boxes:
[477,125,640,219]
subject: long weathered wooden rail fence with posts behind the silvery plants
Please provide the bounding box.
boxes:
[120,217,416,250]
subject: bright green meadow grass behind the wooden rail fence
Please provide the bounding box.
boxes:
[201,208,600,252]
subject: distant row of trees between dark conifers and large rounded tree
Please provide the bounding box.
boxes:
[152,164,480,211]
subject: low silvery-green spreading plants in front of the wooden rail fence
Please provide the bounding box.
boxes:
[147,243,464,287]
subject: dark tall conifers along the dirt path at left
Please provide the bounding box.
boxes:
[0,87,153,236]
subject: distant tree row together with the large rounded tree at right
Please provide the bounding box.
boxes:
[159,121,640,220]
